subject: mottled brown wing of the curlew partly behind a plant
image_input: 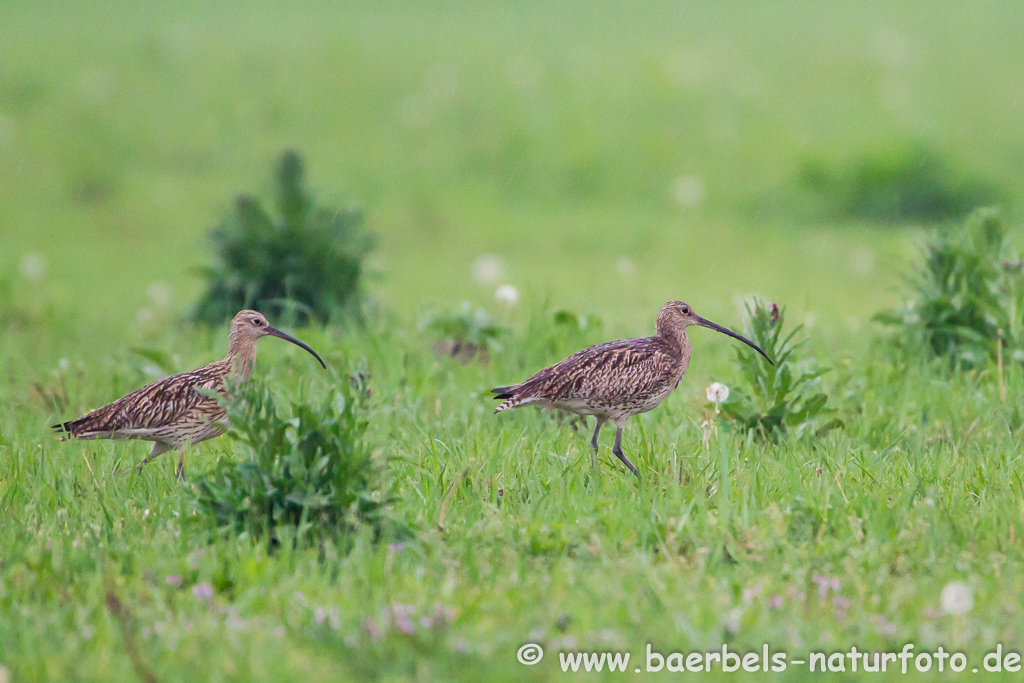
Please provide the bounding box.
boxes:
[53,361,229,437]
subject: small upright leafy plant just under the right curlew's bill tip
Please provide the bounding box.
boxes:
[721,303,843,437]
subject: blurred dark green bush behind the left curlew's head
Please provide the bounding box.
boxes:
[193,151,373,324]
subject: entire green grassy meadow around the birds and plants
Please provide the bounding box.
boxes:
[0,0,1024,683]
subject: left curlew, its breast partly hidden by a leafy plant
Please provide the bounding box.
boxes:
[53,310,327,478]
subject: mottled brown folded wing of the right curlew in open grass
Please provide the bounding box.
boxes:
[515,337,677,401]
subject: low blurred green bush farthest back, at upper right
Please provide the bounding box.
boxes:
[798,141,999,221]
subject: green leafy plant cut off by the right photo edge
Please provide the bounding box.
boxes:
[876,209,1024,367]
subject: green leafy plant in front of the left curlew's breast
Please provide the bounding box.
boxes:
[194,373,384,544]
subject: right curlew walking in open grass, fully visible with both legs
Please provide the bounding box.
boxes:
[492,301,774,476]
